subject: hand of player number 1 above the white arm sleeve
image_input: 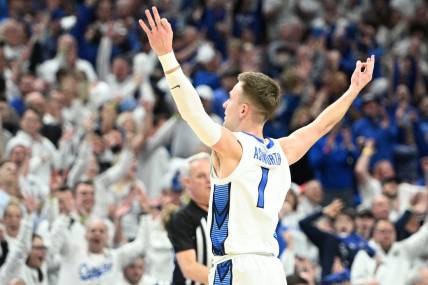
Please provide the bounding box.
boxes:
[138,7,173,56]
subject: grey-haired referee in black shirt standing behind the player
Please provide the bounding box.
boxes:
[167,153,211,285]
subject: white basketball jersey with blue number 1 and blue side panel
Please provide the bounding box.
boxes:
[208,132,291,256]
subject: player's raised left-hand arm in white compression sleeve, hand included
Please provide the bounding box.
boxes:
[139,7,242,162]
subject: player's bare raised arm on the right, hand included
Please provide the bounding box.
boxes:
[280,55,375,164]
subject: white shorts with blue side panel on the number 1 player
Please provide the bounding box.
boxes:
[209,254,287,285]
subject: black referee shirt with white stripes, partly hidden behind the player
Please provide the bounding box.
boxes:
[167,201,211,285]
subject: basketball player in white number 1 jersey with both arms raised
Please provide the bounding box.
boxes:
[139,7,374,285]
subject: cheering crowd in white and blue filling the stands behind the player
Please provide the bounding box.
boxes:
[0,0,428,285]
